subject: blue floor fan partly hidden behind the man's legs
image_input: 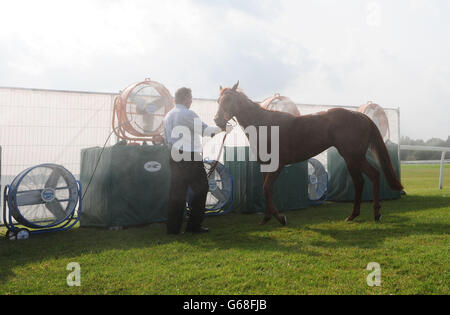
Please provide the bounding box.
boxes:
[187,161,233,216]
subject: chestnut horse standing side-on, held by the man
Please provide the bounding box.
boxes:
[214,82,403,225]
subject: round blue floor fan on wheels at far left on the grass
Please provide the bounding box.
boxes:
[3,164,81,239]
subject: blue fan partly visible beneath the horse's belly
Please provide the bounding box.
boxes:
[308,158,328,204]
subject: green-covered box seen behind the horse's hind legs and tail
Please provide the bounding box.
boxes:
[327,142,401,201]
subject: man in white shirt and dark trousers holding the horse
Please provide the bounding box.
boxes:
[164,88,221,234]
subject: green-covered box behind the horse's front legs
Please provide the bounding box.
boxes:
[224,147,309,213]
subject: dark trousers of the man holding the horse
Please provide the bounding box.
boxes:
[167,154,209,234]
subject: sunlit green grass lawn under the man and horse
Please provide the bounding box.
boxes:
[0,165,450,295]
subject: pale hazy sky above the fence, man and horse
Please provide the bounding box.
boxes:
[0,0,450,139]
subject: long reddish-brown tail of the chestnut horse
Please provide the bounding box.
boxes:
[370,124,403,191]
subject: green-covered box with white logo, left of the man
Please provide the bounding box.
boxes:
[80,145,170,227]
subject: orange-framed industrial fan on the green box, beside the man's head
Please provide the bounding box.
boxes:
[113,79,174,143]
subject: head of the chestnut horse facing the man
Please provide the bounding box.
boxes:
[214,81,240,130]
